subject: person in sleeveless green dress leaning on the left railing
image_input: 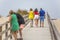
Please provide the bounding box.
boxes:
[9,10,19,40]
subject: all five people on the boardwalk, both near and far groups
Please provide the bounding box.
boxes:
[9,8,45,40]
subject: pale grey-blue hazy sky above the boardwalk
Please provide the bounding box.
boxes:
[0,0,60,18]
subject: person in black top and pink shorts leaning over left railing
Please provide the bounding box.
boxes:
[15,13,25,39]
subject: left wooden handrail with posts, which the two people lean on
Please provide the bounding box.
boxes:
[0,15,29,40]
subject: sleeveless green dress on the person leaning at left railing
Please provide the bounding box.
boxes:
[11,14,19,31]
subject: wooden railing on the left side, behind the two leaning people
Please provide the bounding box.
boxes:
[0,15,29,40]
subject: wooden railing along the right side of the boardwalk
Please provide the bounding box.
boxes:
[47,14,60,40]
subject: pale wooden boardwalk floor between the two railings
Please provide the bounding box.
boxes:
[23,19,52,40]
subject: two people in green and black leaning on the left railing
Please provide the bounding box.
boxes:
[9,10,25,40]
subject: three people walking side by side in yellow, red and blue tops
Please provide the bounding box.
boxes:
[29,8,45,27]
